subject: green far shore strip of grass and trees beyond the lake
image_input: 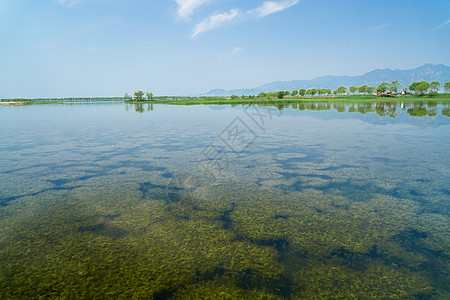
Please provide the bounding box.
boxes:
[0,80,450,105]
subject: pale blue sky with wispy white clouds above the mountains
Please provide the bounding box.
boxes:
[0,0,450,98]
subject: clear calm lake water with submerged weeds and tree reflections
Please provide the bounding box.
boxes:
[0,103,450,299]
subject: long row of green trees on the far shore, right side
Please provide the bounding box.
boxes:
[255,80,450,99]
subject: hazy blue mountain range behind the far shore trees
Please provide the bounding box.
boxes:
[204,64,450,96]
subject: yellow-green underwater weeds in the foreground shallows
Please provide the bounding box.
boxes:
[0,178,450,299]
